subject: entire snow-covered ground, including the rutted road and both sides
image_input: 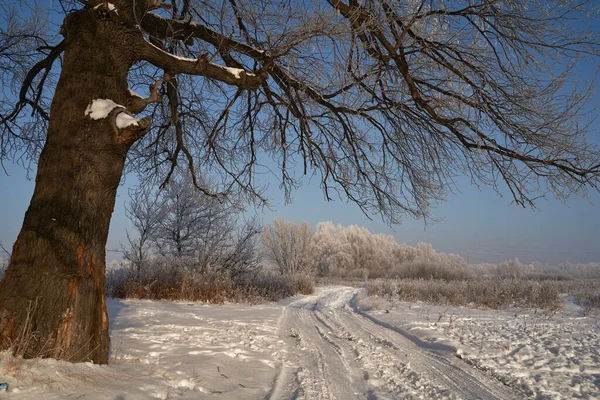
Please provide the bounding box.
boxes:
[0,287,600,400]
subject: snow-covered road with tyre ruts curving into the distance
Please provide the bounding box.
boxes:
[270,287,520,399]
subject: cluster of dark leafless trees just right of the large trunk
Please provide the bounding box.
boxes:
[123,173,261,278]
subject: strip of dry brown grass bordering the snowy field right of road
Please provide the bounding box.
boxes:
[362,279,561,310]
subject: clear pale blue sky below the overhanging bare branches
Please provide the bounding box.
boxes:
[0,3,600,264]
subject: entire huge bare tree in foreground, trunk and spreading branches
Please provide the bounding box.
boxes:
[0,0,600,363]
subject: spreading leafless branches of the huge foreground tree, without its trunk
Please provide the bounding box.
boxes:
[0,0,600,222]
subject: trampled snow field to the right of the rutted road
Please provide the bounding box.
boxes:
[364,290,600,399]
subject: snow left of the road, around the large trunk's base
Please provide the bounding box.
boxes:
[0,299,284,400]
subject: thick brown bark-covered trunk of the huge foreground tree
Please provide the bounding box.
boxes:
[0,10,137,363]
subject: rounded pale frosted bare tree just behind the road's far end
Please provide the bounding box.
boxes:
[262,218,314,274]
